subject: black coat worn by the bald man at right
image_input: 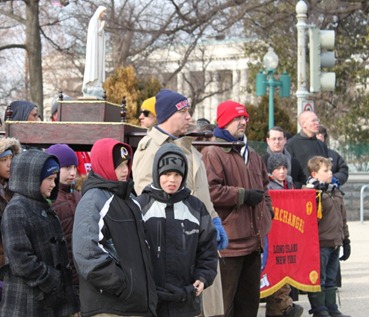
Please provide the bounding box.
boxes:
[286,131,329,178]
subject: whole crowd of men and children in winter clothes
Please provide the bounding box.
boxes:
[0,89,350,317]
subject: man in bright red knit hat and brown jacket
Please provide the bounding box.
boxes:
[201,100,273,317]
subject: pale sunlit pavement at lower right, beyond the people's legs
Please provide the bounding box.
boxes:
[258,221,369,317]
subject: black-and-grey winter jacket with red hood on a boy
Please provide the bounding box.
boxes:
[72,139,157,316]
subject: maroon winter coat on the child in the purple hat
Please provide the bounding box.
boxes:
[52,183,81,287]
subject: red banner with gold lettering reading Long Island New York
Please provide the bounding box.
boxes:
[260,189,320,297]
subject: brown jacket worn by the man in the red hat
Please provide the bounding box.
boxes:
[201,139,273,257]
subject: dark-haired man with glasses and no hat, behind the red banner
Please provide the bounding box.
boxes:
[263,126,306,189]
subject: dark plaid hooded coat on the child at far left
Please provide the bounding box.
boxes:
[0,150,78,317]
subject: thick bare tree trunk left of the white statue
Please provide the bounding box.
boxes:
[26,0,44,114]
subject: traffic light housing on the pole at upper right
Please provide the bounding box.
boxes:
[309,26,336,92]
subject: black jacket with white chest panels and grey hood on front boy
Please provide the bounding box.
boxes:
[137,143,218,317]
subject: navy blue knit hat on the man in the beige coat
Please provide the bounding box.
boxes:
[155,89,190,124]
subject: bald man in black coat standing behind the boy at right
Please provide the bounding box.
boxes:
[286,111,329,178]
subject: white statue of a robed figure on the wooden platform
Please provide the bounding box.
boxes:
[82,6,106,99]
